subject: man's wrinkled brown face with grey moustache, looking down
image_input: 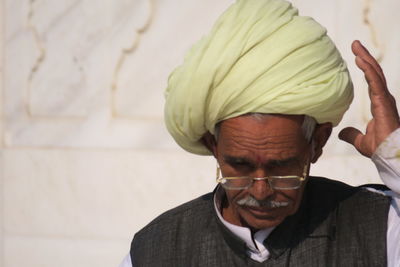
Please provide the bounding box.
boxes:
[216,115,310,229]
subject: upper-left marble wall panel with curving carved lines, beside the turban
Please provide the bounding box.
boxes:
[4,0,230,148]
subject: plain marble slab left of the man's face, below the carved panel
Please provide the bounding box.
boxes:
[3,149,215,239]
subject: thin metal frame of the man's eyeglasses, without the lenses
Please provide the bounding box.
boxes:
[216,160,309,190]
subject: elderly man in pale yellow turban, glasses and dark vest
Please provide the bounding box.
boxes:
[122,0,400,267]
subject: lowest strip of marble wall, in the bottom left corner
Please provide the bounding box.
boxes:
[4,236,128,267]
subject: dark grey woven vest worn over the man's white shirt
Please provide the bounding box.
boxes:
[130,177,390,267]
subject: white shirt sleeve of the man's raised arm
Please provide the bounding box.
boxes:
[371,128,400,267]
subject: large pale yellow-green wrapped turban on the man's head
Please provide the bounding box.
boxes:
[165,0,353,155]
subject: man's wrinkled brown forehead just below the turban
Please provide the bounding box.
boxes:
[217,114,307,164]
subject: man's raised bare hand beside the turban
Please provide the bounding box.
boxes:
[339,41,400,157]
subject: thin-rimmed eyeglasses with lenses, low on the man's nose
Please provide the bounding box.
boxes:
[217,161,308,190]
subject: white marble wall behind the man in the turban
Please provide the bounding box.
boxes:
[0,0,400,267]
